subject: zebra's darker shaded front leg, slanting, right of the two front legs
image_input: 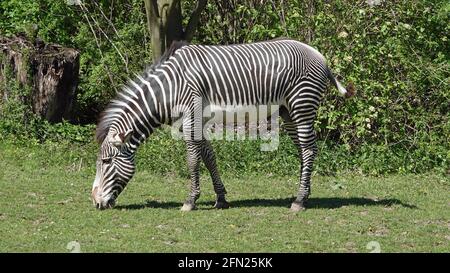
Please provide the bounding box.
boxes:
[201,140,230,209]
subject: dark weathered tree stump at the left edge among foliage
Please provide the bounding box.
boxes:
[0,34,80,122]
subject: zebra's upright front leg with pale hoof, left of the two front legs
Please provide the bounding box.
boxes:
[181,140,202,211]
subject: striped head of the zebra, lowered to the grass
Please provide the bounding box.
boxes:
[91,130,135,209]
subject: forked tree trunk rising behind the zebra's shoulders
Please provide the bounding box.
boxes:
[144,0,207,60]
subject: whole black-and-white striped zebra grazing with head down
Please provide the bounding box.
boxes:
[91,38,355,212]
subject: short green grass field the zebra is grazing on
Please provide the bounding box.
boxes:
[0,143,450,252]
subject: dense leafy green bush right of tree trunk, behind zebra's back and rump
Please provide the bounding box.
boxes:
[194,0,450,173]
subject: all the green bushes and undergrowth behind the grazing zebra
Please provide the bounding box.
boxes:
[0,0,450,175]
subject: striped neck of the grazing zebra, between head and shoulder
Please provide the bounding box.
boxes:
[106,60,184,150]
